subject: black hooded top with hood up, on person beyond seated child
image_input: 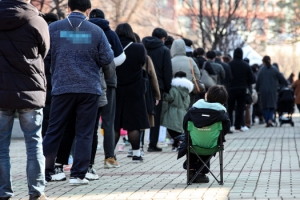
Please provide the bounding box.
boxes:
[228,48,255,89]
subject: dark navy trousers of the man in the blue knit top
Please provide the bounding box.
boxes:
[43,93,99,181]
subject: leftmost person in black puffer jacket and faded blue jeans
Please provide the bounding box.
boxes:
[0,0,50,200]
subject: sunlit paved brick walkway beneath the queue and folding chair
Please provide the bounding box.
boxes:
[6,115,300,200]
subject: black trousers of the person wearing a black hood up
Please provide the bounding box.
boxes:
[228,88,246,129]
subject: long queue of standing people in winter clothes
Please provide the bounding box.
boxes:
[0,0,300,200]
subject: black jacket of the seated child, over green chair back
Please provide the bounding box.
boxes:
[177,107,230,159]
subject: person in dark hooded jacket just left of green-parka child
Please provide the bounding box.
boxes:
[142,28,173,152]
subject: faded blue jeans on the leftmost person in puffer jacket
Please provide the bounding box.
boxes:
[0,108,45,197]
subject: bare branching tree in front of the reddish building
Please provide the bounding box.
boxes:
[186,0,257,53]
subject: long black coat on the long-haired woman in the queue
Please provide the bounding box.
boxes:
[114,37,150,131]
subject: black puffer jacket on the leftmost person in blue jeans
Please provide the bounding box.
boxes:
[0,0,50,109]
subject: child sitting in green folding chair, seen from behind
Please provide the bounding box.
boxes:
[178,85,230,185]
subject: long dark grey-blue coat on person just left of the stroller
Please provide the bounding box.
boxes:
[255,66,288,109]
